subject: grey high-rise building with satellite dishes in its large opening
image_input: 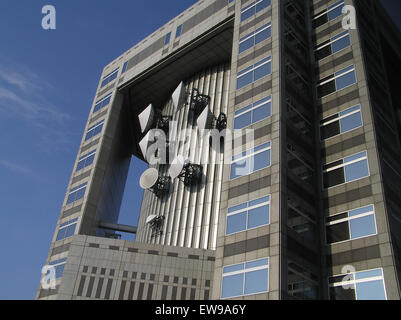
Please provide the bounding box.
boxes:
[37,0,401,300]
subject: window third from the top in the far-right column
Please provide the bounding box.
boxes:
[317,65,356,98]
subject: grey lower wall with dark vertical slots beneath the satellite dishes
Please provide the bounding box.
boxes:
[39,235,215,300]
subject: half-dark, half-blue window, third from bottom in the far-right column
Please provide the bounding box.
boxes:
[323,151,370,189]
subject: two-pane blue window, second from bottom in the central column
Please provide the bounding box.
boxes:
[226,196,270,235]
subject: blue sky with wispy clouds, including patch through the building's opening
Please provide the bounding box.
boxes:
[0,0,400,299]
